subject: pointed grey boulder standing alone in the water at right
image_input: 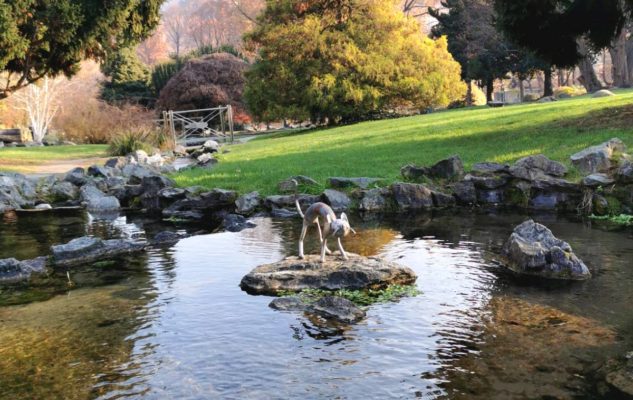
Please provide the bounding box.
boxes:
[502,220,591,280]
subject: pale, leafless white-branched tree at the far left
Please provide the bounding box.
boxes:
[15,77,60,143]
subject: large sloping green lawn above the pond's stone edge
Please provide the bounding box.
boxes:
[174,90,633,194]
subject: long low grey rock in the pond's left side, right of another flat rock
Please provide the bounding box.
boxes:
[51,236,145,267]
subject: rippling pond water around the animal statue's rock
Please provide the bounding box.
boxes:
[0,211,633,399]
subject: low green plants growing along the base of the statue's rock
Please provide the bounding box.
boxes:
[279,285,420,306]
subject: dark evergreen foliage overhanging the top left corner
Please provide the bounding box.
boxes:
[0,0,164,98]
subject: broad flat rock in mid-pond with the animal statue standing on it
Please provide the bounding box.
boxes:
[240,253,417,295]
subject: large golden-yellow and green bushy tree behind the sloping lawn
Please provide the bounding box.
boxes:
[244,0,465,124]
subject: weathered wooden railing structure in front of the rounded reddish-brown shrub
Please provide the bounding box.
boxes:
[162,105,234,146]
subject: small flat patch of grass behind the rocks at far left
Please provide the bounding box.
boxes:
[0,144,108,173]
